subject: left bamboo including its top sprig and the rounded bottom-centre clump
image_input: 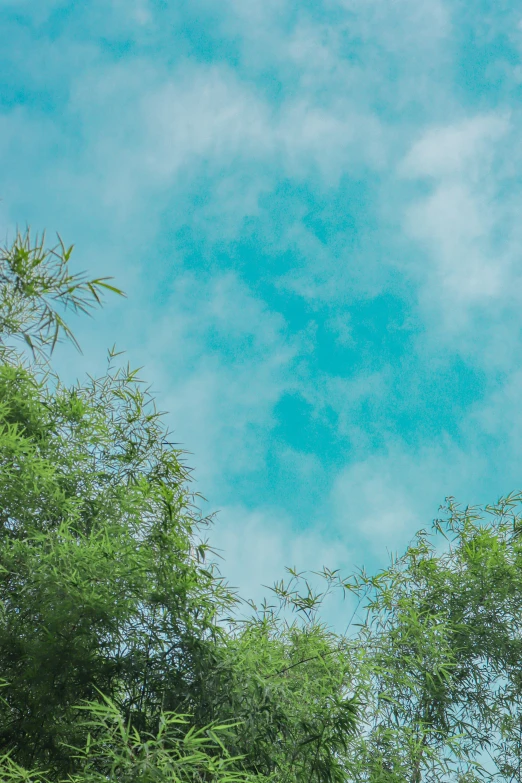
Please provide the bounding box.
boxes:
[0,232,355,783]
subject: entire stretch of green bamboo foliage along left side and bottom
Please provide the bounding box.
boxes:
[0,233,522,783]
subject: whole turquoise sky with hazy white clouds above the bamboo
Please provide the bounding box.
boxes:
[0,0,522,612]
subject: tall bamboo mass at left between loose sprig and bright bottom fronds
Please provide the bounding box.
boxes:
[0,346,237,769]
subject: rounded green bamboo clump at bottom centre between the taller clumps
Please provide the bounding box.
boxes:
[195,596,356,783]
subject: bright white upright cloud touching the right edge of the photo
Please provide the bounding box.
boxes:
[399,113,522,361]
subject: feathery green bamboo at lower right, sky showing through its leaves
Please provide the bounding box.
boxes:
[349,493,522,783]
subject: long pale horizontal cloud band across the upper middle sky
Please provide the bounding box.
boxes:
[141,67,380,185]
